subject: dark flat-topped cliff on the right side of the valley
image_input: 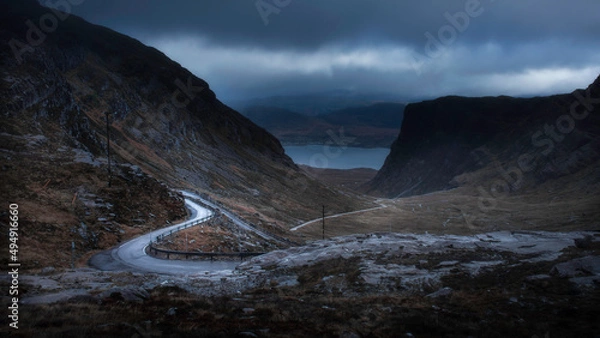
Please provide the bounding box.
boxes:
[367,78,600,197]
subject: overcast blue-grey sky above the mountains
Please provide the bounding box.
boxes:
[45,0,600,102]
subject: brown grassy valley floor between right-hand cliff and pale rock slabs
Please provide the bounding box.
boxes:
[296,187,600,240]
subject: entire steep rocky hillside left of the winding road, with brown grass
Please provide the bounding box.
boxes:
[0,0,364,270]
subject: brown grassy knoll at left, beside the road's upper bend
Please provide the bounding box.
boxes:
[0,140,187,270]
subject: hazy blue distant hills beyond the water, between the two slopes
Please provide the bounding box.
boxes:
[243,103,405,147]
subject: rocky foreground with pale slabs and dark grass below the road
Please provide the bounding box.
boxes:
[2,231,600,337]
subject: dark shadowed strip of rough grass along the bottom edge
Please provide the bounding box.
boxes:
[7,277,600,337]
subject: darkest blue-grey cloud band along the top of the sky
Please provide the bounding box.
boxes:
[55,0,600,48]
